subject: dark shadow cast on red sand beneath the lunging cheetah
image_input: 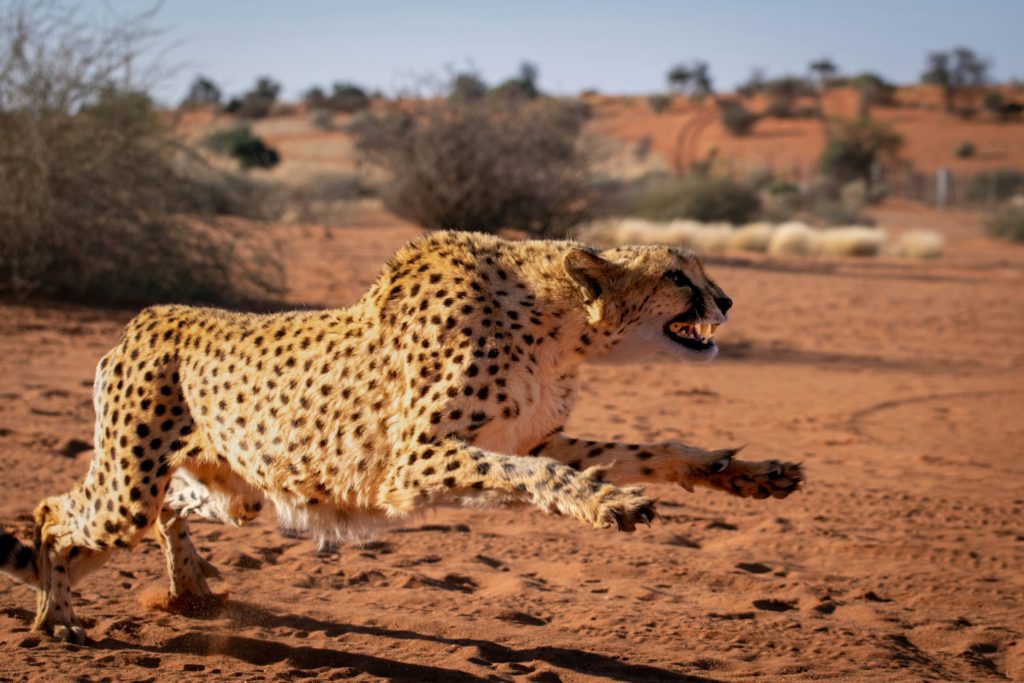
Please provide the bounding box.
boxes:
[93,600,717,683]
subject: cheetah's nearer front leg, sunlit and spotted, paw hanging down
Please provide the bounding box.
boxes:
[381,437,654,531]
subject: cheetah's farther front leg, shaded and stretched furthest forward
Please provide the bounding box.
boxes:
[528,433,804,499]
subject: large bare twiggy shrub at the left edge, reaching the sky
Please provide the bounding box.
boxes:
[0,2,281,302]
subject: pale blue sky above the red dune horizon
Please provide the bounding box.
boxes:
[97,0,1024,100]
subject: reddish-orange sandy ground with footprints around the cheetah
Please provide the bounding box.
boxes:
[0,205,1024,681]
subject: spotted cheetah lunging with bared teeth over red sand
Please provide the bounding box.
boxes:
[0,231,803,642]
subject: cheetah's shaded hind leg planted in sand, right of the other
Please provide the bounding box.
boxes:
[141,507,227,616]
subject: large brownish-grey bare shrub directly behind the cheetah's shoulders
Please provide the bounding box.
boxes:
[350,97,595,236]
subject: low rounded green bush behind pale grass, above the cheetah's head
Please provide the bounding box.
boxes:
[625,174,761,224]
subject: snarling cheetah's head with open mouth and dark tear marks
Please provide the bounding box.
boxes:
[564,246,732,361]
